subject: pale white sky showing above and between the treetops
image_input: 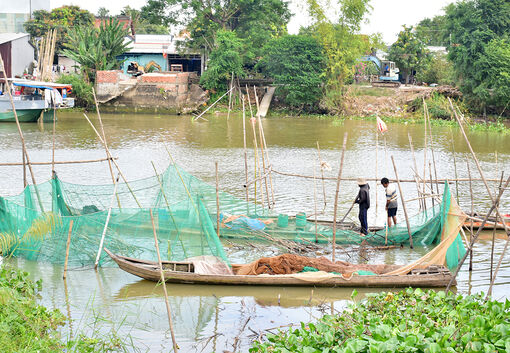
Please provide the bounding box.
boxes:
[51,0,454,44]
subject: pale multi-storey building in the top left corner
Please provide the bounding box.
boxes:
[0,0,51,33]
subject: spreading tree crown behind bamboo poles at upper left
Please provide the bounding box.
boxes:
[24,6,94,53]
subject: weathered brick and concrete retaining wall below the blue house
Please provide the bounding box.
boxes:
[96,70,207,114]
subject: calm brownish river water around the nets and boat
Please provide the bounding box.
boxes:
[0,113,510,352]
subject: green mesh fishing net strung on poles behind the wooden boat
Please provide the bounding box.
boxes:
[0,165,462,266]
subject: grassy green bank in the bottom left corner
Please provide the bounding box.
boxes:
[0,266,131,352]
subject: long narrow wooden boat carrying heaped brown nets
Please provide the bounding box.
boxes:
[104,248,456,288]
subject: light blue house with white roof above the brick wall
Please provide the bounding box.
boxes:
[119,34,204,75]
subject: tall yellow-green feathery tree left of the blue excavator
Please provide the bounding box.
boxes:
[307,0,380,113]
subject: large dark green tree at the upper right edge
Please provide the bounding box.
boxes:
[446,0,510,114]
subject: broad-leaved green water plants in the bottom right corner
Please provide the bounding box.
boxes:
[250,288,510,353]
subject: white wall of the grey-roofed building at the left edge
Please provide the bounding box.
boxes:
[0,33,35,77]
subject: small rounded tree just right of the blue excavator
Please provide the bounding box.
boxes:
[388,26,429,83]
